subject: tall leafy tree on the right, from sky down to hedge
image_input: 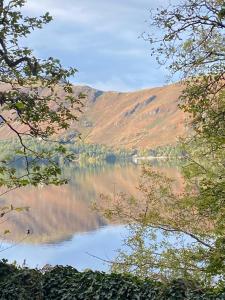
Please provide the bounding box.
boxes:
[99,0,225,284]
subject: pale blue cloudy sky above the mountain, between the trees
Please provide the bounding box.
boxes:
[25,0,171,91]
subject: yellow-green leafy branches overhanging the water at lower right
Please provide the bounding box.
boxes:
[97,167,225,286]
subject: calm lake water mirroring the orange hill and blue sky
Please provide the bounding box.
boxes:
[0,164,181,270]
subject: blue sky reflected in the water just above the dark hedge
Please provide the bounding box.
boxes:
[0,226,127,271]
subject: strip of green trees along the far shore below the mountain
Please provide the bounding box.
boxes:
[0,133,184,171]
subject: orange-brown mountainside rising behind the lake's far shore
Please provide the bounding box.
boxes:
[0,84,187,148]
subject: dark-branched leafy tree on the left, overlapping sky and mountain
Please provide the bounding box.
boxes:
[0,0,83,193]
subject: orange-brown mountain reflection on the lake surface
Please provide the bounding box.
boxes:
[2,164,181,243]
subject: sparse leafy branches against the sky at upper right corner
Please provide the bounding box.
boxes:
[144,0,225,78]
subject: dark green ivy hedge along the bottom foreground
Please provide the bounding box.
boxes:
[0,262,225,300]
